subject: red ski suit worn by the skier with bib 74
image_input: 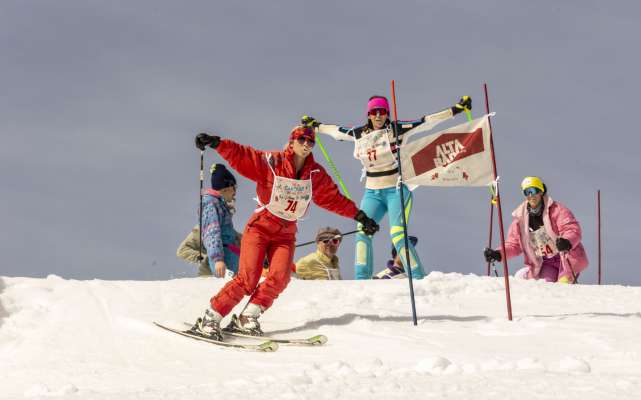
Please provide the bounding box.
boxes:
[211,139,358,316]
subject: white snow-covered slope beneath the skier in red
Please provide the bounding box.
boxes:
[0,272,641,400]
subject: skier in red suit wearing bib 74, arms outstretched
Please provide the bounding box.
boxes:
[192,126,379,340]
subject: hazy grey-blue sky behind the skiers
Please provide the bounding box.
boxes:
[0,0,641,285]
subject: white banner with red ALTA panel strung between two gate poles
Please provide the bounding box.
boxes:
[401,115,494,190]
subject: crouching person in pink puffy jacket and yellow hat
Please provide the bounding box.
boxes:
[483,176,588,283]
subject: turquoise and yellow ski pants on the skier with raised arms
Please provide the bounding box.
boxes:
[354,185,425,279]
